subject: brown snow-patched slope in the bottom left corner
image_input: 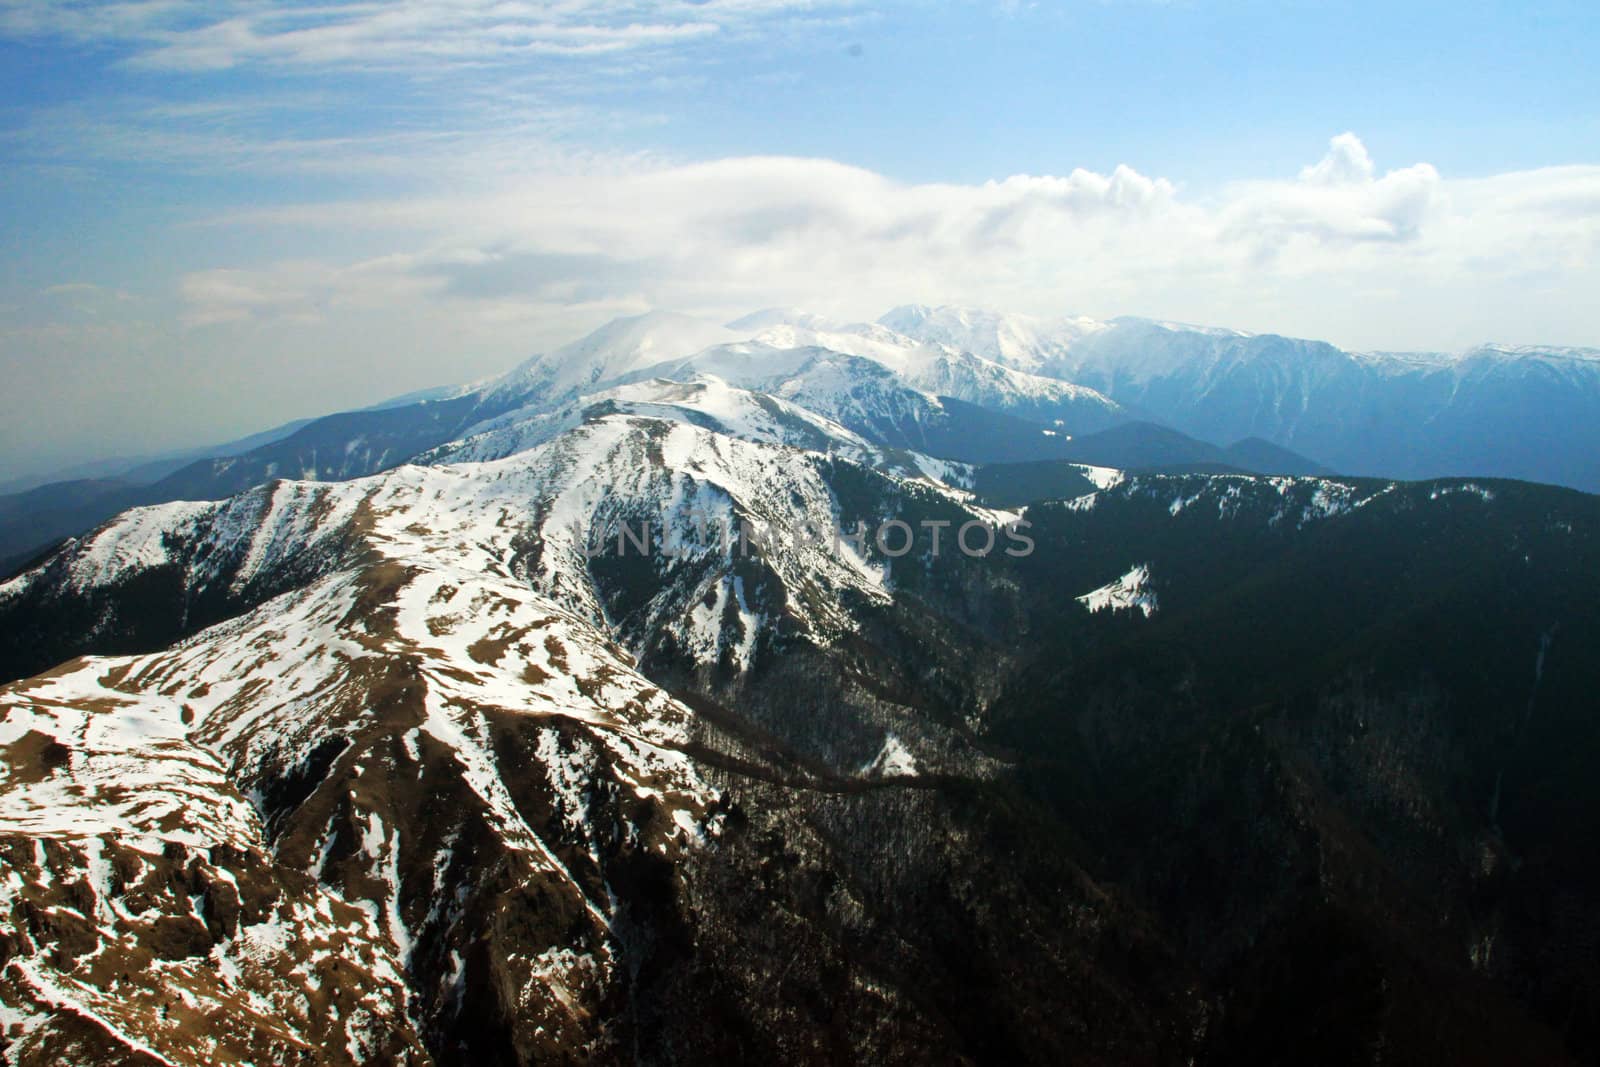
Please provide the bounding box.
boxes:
[0,659,427,1064]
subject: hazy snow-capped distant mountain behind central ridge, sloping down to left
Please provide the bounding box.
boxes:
[0,312,1123,573]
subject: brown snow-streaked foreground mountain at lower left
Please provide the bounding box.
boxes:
[0,469,715,1064]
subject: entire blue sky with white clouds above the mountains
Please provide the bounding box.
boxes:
[0,0,1600,478]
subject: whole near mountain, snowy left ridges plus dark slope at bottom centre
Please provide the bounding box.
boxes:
[0,404,1209,1062]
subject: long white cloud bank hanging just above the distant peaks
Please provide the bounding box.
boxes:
[172,134,1600,347]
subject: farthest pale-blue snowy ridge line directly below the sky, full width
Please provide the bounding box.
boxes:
[12,306,1600,571]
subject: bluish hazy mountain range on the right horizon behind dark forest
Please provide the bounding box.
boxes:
[883,307,1600,491]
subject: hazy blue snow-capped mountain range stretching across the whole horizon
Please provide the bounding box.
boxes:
[9,306,1600,573]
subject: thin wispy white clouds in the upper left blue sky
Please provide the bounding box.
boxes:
[0,0,870,182]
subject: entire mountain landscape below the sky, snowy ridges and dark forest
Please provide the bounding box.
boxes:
[9,307,1600,1065]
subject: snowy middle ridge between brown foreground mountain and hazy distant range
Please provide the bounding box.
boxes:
[0,409,1011,684]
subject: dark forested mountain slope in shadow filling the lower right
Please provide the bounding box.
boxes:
[995,475,1600,1062]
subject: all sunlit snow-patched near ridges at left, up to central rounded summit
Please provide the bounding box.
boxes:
[0,398,1036,1062]
